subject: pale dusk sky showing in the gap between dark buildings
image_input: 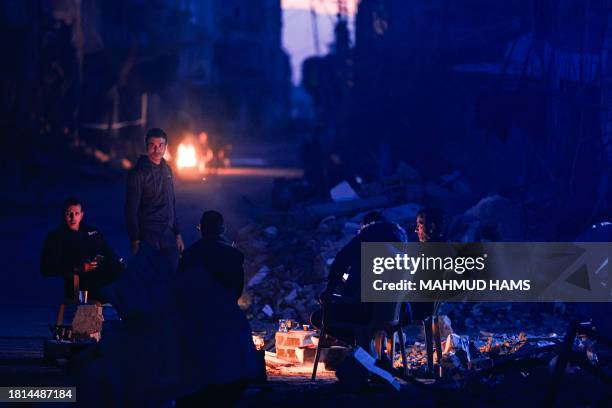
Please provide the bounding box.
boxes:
[282,0,357,84]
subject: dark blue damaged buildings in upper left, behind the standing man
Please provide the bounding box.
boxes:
[0,0,290,180]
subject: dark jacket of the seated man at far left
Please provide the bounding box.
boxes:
[40,224,122,300]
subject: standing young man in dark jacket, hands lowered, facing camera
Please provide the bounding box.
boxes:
[125,128,185,270]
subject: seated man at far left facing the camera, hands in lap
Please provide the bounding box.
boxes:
[40,198,123,303]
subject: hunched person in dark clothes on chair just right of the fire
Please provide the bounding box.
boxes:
[311,212,406,347]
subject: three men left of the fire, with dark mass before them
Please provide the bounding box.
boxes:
[40,129,260,406]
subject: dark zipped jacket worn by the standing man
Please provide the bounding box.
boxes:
[125,156,180,241]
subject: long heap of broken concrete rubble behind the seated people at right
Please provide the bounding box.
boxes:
[236,164,563,340]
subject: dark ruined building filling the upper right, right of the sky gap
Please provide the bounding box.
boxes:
[305,0,610,239]
